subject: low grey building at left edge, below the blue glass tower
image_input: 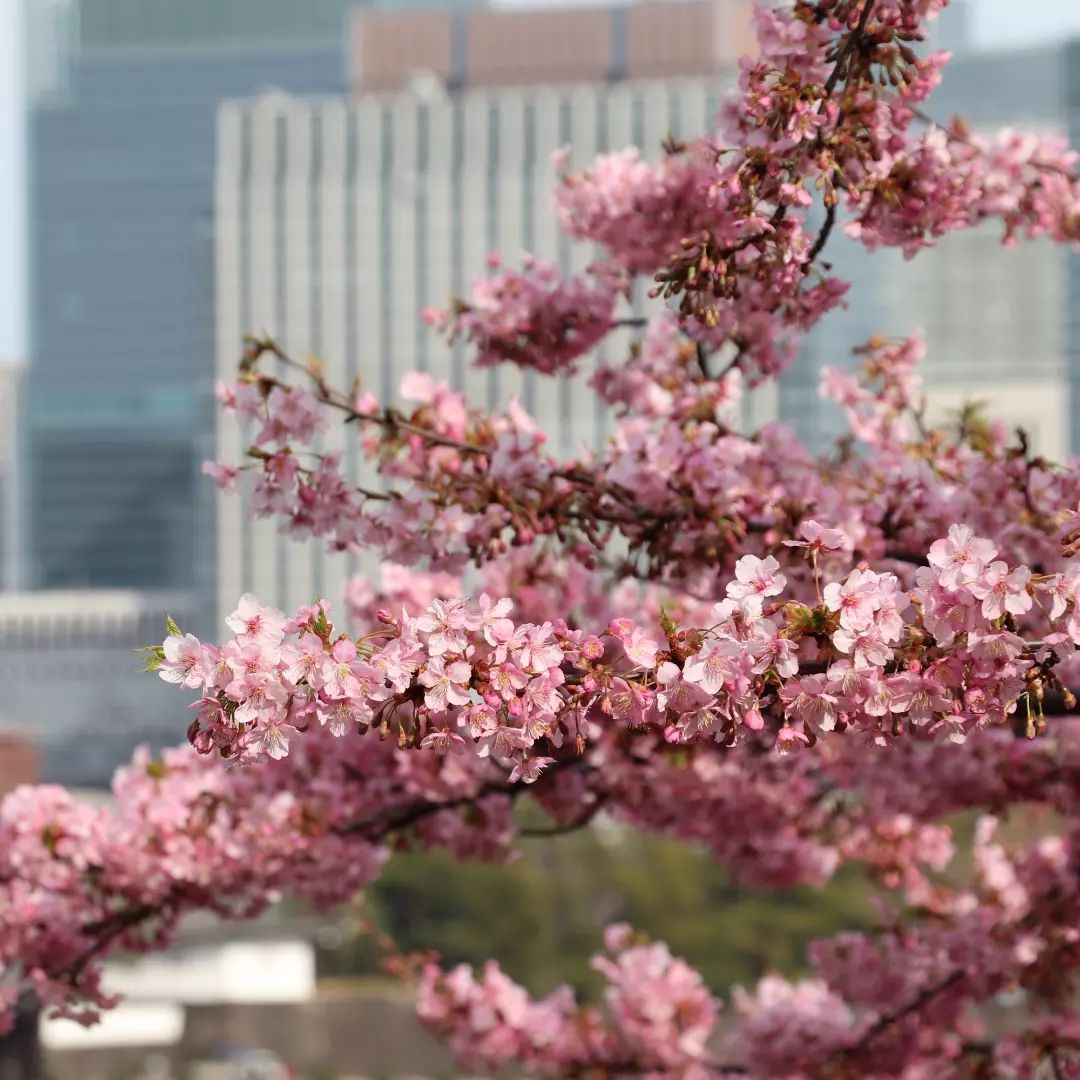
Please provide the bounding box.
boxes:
[0,590,194,787]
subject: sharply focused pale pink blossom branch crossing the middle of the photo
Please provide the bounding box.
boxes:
[156,521,1080,781]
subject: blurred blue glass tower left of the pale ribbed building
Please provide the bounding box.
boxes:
[22,0,479,622]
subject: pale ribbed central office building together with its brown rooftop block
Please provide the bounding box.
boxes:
[206,0,748,617]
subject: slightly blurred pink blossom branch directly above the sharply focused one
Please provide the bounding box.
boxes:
[214,318,1080,595]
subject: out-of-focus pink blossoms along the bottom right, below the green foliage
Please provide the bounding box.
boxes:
[420,819,1080,1080]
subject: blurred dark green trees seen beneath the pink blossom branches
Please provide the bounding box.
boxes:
[322,823,870,995]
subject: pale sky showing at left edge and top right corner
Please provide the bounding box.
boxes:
[0,0,1080,362]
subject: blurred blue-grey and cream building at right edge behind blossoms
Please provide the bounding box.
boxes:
[779,39,1067,460]
